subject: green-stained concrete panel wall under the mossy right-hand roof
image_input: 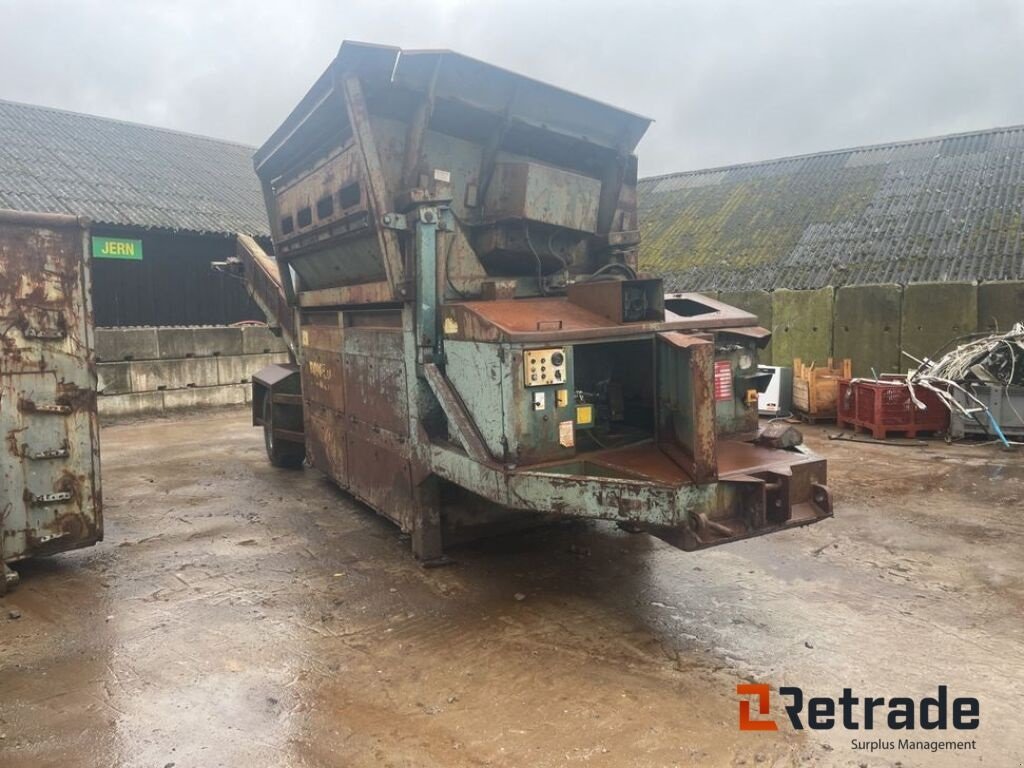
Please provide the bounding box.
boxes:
[709,282,1024,377]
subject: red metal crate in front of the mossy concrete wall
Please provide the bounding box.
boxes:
[836,377,949,440]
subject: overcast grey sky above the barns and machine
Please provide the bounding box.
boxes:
[0,0,1024,175]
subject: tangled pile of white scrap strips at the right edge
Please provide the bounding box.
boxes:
[904,323,1024,445]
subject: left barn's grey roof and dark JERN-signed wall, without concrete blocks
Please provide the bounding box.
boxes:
[0,100,269,327]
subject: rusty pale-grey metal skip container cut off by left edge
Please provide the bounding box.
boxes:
[0,210,103,591]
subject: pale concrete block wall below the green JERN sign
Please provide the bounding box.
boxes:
[96,326,288,416]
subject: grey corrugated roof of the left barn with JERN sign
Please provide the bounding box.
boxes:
[0,100,268,236]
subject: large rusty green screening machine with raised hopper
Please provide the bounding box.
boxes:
[241,42,831,560]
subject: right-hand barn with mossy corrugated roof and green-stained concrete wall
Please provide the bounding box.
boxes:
[638,126,1024,375]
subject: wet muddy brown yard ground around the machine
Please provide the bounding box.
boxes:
[0,410,1024,768]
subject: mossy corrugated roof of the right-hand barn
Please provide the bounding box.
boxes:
[638,126,1024,291]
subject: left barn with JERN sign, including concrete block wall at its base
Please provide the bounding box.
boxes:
[0,100,289,417]
